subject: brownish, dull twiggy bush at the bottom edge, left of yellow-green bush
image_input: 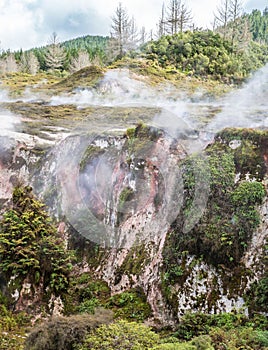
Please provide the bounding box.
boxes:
[25,309,112,350]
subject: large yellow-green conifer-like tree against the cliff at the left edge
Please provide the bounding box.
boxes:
[0,187,71,295]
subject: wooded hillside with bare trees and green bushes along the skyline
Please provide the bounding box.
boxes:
[0,0,268,81]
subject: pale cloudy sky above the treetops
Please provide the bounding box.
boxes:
[0,0,268,50]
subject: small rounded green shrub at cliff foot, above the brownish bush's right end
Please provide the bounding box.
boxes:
[106,290,152,321]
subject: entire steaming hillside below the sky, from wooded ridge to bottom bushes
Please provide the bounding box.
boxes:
[0,7,268,350]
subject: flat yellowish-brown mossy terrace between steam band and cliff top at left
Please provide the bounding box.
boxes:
[3,101,159,143]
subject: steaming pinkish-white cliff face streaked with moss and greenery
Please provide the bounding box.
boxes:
[0,102,268,325]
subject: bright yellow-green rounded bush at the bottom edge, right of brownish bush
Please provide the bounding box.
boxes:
[79,320,160,350]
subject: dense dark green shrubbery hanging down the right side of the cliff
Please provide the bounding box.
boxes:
[164,132,265,266]
